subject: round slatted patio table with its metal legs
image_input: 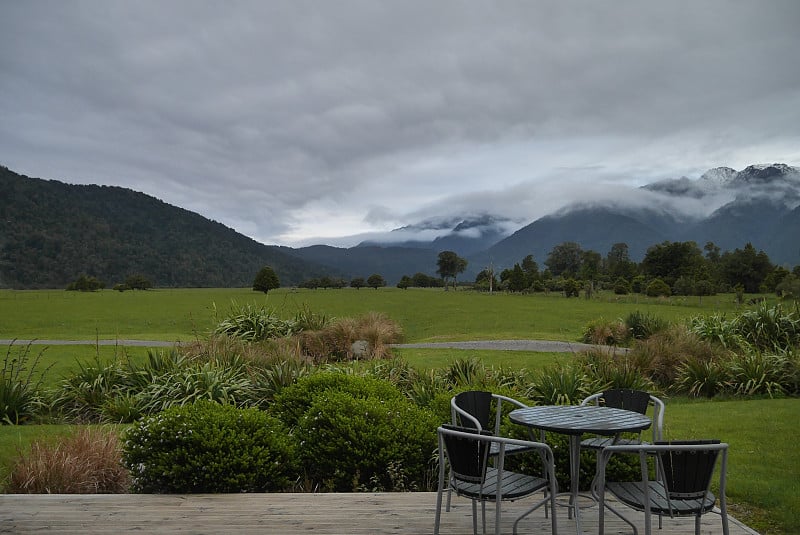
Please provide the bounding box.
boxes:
[509,405,652,533]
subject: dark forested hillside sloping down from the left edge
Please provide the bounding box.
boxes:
[0,167,332,288]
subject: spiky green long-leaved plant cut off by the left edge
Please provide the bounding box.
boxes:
[0,343,48,424]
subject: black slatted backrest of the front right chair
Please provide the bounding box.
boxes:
[655,440,720,500]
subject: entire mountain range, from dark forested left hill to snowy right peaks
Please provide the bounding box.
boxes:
[0,164,800,288]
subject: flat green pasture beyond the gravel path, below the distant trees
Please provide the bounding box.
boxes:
[0,288,760,342]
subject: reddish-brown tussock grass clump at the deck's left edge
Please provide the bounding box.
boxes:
[6,427,130,494]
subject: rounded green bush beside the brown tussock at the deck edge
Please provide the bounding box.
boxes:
[123,401,297,493]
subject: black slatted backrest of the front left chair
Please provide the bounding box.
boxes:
[439,425,493,483]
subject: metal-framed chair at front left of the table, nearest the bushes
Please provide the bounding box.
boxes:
[433,425,558,535]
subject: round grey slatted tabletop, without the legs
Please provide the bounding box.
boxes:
[509,405,652,435]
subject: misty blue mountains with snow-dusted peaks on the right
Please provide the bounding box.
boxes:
[364,164,800,278]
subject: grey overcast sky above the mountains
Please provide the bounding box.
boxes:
[0,0,800,245]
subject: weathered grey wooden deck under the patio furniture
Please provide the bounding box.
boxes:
[0,492,755,535]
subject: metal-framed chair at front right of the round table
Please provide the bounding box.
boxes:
[595,440,728,535]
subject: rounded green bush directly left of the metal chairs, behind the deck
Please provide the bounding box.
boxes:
[295,390,440,492]
